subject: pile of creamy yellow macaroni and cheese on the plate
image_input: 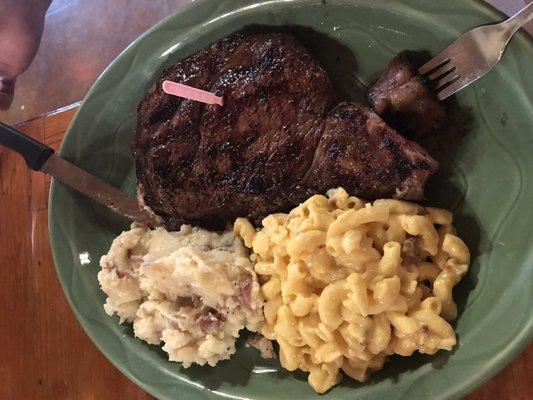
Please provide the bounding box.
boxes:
[235,188,470,393]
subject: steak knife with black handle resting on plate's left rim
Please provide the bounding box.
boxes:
[0,122,155,226]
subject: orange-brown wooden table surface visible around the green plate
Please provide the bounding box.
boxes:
[0,105,533,400]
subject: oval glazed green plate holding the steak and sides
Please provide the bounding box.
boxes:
[50,0,533,399]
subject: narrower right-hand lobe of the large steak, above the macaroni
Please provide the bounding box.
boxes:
[303,103,438,199]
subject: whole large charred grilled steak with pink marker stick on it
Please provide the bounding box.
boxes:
[134,34,436,229]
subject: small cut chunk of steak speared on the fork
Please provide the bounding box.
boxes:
[367,53,444,138]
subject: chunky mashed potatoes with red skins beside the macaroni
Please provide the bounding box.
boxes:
[98,224,264,367]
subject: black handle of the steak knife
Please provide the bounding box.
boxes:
[0,122,54,171]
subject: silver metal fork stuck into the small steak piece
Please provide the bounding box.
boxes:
[418,3,533,100]
